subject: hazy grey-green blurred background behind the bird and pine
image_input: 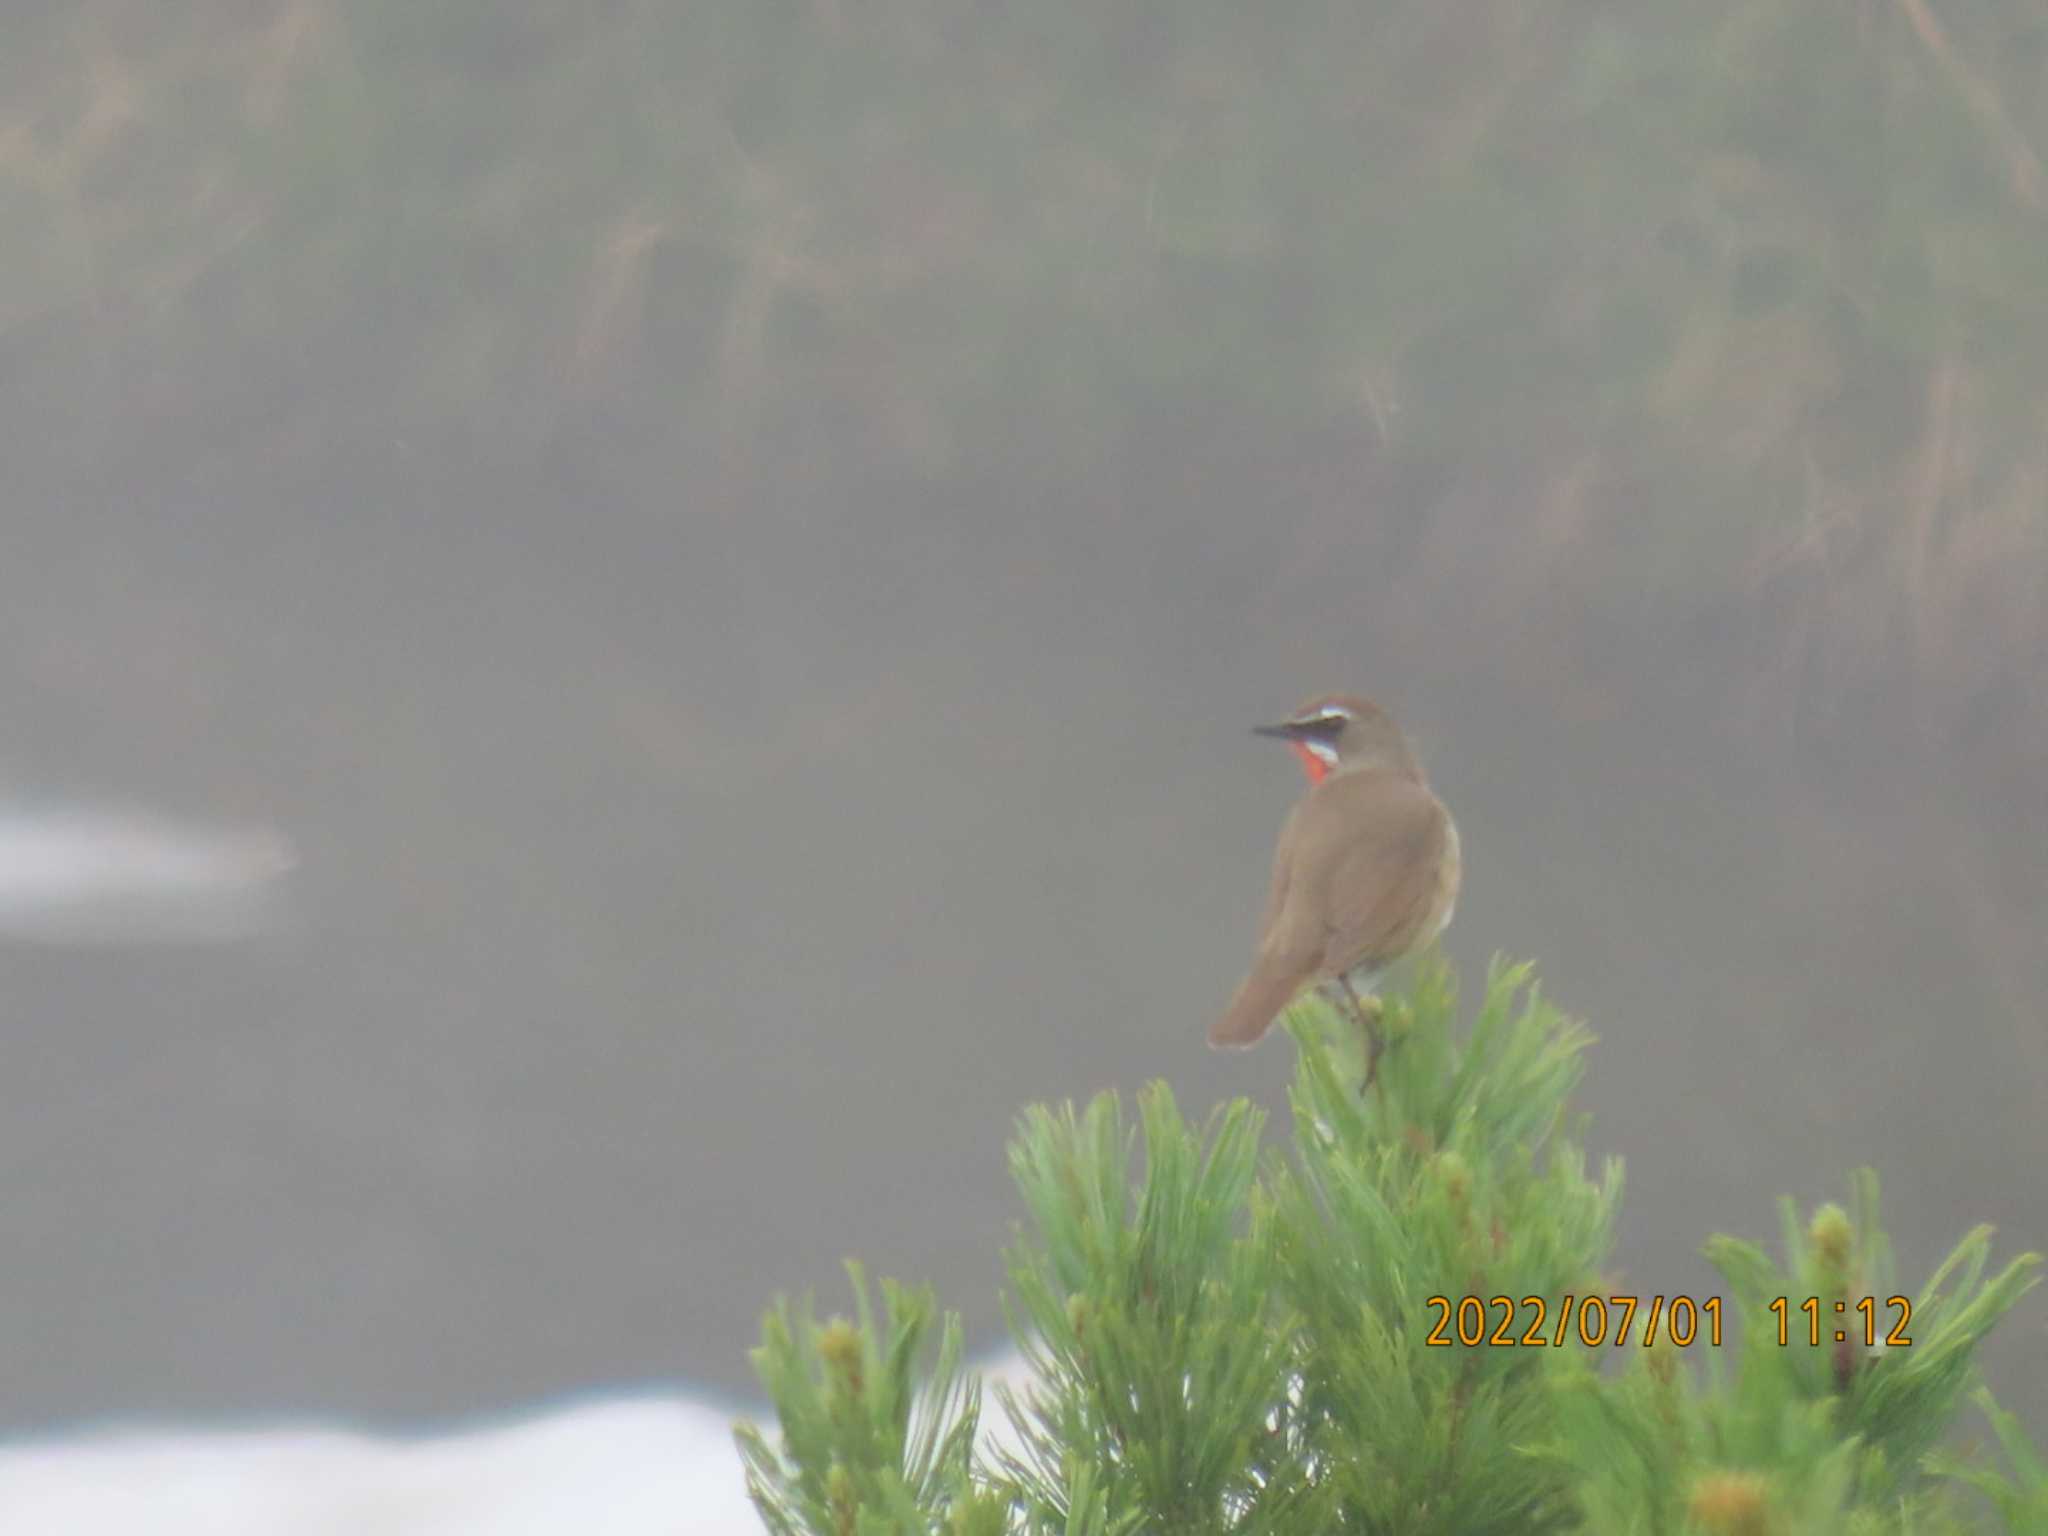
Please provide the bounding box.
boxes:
[0,0,2048,1434]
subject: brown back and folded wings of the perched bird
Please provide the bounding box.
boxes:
[1296,772,1448,975]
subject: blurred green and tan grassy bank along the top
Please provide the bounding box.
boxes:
[0,0,2048,729]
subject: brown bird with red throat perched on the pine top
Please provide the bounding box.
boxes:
[1208,694,1458,1087]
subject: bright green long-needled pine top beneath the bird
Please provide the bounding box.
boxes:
[737,965,2048,1536]
